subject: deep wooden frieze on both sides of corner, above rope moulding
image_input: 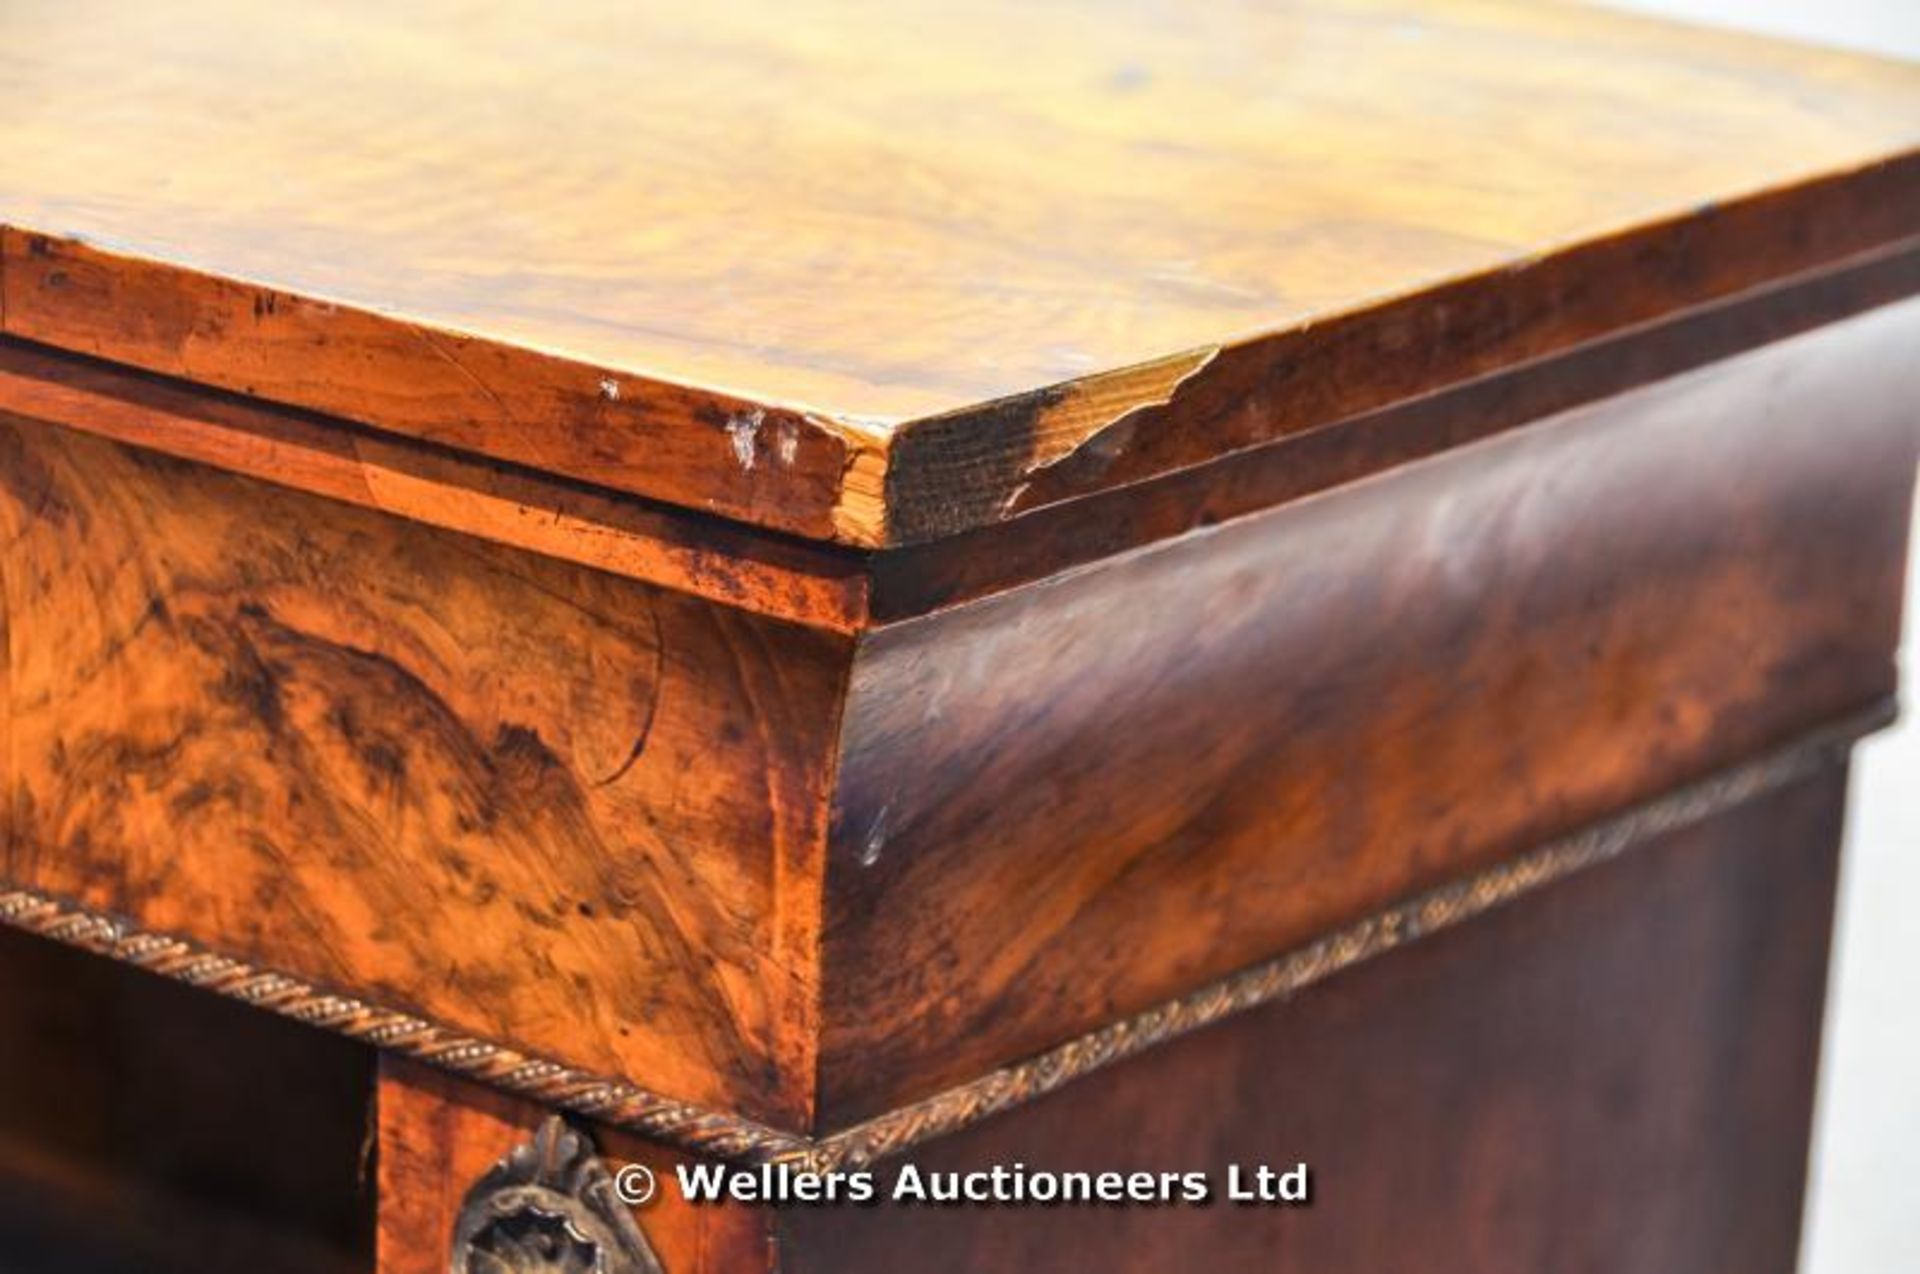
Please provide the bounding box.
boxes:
[0,303,1920,1134]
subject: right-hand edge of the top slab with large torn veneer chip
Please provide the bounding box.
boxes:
[883,171,1920,543]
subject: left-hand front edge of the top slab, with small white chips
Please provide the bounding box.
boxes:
[0,221,883,543]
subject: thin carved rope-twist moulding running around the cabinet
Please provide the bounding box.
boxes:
[0,698,1899,1172]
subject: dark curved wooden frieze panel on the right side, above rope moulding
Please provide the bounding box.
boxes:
[820,303,1920,1130]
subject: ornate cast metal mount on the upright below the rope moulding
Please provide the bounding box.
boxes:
[449,1115,662,1274]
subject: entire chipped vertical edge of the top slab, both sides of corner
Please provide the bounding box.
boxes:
[0,150,1920,549]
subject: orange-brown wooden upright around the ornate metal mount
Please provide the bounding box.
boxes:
[374,1059,774,1274]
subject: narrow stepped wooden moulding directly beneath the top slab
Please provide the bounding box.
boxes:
[0,236,1920,637]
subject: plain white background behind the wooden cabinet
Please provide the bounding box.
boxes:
[1613,0,1920,1274]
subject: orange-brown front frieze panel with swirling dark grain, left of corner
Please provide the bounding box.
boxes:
[0,420,849,1124]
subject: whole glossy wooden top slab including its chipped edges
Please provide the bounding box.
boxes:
[0,0,1920,545]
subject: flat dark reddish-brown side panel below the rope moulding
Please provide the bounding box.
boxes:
[780,769,1845,1274]
